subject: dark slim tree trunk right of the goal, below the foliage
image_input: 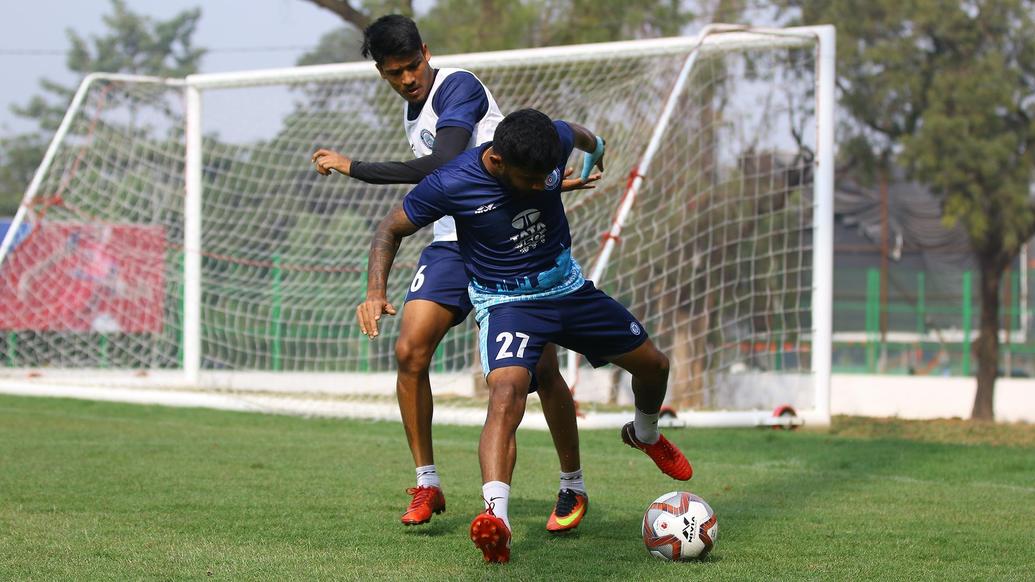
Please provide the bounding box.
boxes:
[971,253,1009,420]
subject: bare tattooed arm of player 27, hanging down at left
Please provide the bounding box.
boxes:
[356,204,420,340]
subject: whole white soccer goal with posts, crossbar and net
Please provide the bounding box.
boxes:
[0,27,833,424]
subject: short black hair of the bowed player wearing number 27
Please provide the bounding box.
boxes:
[493,109,564,172]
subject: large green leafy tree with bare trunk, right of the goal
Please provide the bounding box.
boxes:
[782,0,1035,420]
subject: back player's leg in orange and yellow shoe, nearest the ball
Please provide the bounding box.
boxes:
[535,344,589,533]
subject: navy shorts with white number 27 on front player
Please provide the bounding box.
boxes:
[478,281,647,386]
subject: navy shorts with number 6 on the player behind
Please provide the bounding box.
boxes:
[406,240,472,325]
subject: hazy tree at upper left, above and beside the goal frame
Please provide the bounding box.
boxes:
[0,0,205,213]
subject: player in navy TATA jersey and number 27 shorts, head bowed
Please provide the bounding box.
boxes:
[356,109,692,562]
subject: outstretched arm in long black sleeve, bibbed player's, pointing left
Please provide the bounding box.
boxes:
[313,126,471,184]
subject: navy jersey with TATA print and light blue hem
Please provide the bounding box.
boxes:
[403,121,575,295]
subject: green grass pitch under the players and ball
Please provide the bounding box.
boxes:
[0,397,1035,580]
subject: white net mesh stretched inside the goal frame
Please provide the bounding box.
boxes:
[0,31,816,407]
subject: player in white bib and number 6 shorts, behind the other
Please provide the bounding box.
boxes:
[313,14,599,532]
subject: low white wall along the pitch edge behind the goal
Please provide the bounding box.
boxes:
[0,368,1035,423]
